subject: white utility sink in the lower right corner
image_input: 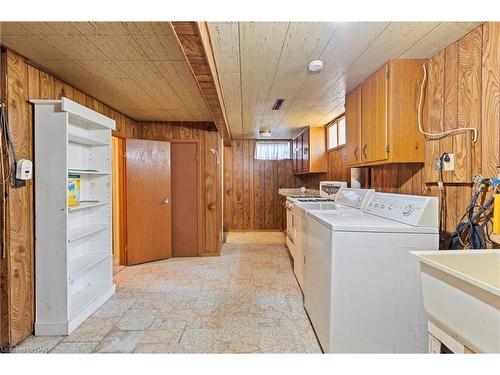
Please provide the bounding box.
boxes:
[413,250,500,353]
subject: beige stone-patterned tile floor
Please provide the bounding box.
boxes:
[14,232,320,353]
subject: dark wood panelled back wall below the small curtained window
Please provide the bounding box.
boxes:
[224,139,326,231]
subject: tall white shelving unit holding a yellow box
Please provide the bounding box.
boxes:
[31,98,116,336]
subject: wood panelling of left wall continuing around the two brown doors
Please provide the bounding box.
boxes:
[0,50,222,347]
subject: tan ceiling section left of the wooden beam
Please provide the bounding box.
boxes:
[0,22,212,121]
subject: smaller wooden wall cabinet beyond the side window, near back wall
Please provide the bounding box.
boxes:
[292,126,328,174]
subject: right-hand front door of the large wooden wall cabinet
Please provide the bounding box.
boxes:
[361,65,388,163]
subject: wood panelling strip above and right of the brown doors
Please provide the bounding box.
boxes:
[141,122,222,255]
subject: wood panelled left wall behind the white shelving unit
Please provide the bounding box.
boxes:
[1,50,141,344]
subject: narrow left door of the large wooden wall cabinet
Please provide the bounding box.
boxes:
[345,86,361,164]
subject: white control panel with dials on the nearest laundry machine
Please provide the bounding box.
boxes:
[365,193,439,227]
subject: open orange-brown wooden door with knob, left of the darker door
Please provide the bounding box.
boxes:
[126,139,172,265]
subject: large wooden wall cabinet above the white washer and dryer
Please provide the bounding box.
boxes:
[346,60,425,166]
